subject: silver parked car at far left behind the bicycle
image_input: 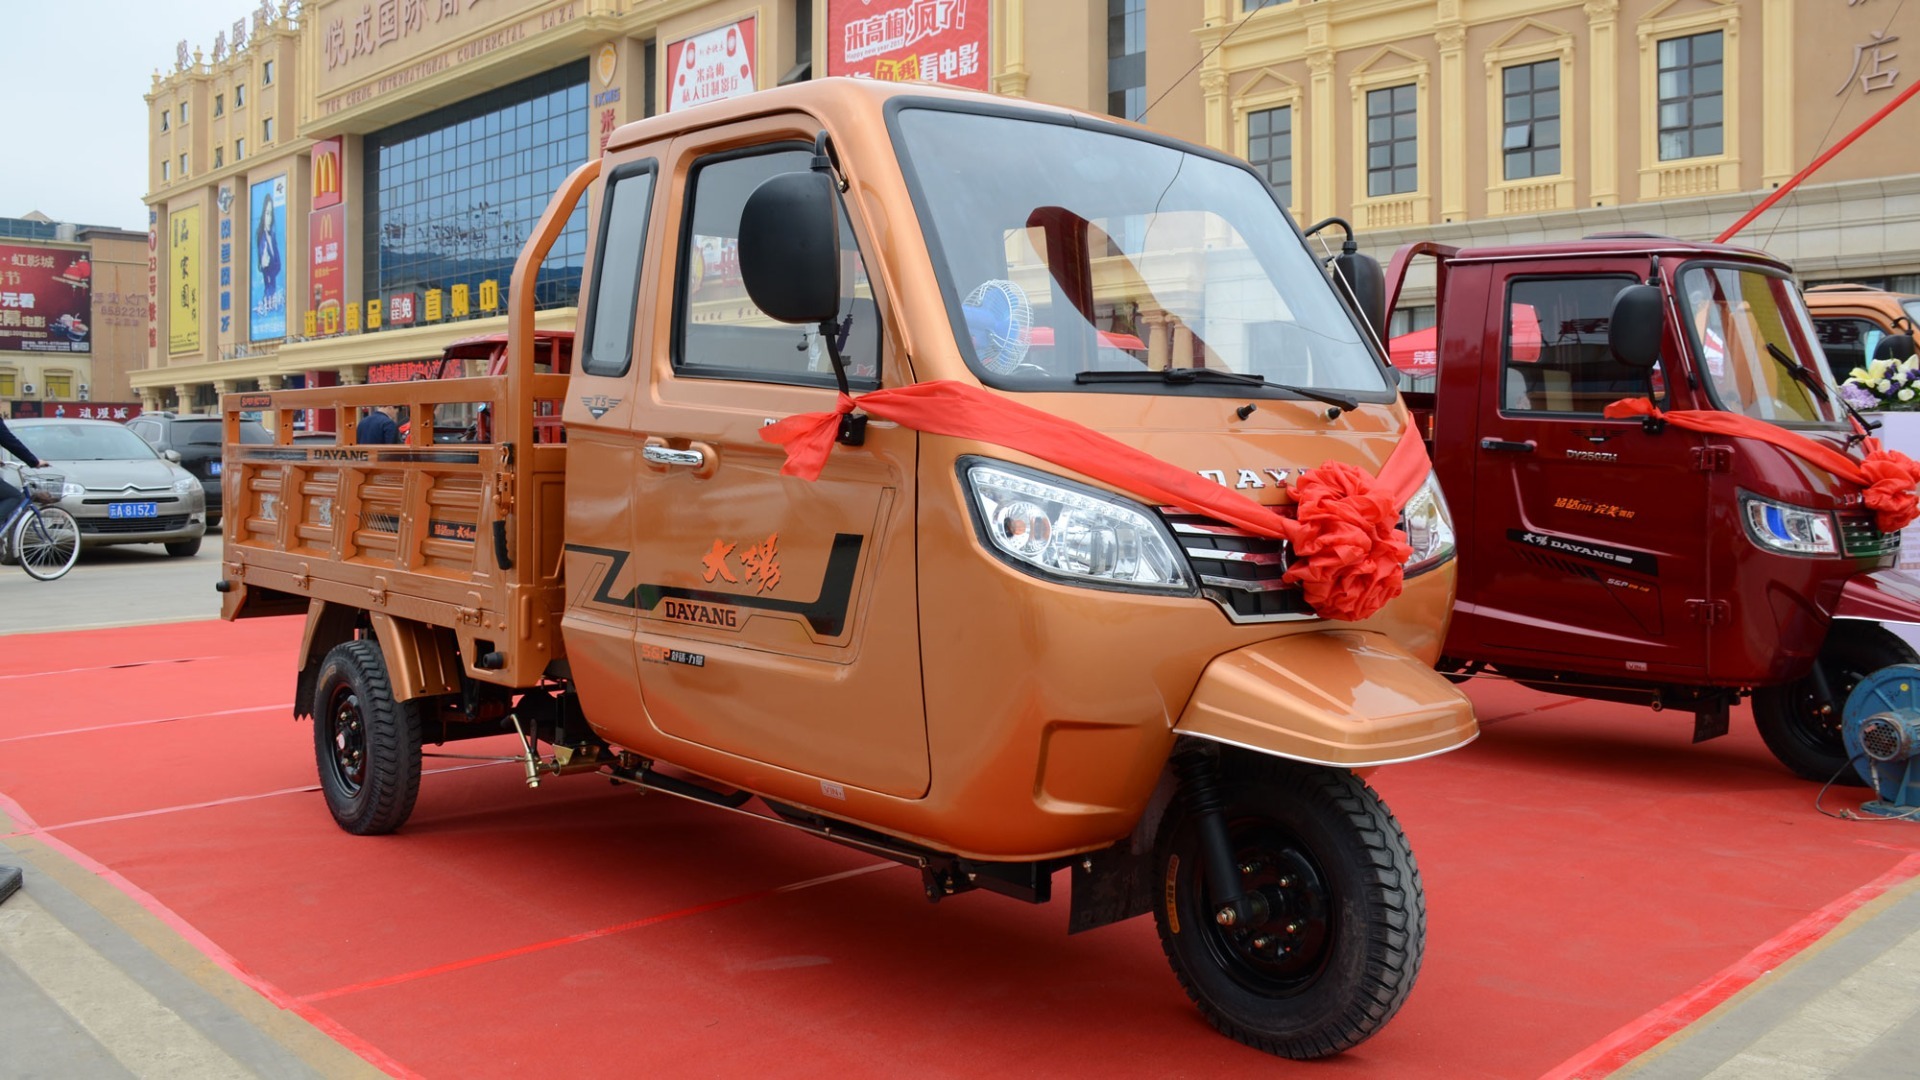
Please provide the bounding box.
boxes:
[0,419,206,557]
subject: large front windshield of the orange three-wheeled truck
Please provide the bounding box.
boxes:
[897,108,1388,394]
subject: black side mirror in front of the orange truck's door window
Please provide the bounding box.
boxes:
[739,171,841,323]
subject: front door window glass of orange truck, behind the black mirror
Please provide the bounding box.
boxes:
[674,144,879,388]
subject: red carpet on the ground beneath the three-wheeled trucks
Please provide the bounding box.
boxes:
[0,621,1920,1078]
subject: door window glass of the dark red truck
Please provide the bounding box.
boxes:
[1500,275,1667,415]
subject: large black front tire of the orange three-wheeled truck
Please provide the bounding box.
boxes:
[1154,751,1427,1061]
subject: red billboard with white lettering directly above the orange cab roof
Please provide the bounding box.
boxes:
[828,0,989,90]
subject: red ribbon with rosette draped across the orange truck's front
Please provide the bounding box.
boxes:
[760,380,1432,621]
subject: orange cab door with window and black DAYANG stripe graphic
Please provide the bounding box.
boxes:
[632,115,927,796]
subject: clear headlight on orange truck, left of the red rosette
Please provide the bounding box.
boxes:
[960,457,1192,592]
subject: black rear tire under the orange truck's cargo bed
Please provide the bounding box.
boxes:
[313,642,420,836]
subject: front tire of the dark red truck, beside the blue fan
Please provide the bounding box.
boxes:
[1753,619,1920,788]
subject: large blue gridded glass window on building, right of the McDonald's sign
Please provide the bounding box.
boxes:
[361,60,588,317]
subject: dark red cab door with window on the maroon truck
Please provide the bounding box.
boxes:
[1455,261,1709,676]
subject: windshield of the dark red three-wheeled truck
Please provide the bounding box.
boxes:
[1680,263,1841,427]
